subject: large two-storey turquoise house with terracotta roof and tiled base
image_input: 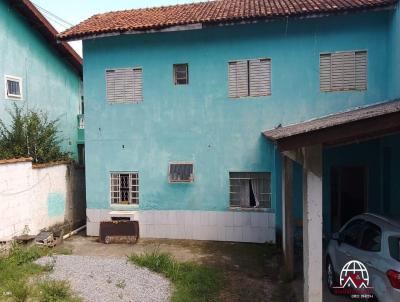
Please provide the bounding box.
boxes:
[59,0,400,249]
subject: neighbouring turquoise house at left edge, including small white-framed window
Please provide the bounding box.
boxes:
[0,0,84,161]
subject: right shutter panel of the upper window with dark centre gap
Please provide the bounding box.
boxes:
[249,59,271,96]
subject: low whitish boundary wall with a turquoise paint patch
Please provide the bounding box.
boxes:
[0,161,86,241]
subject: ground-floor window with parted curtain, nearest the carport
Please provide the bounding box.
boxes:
[229,172,271,208]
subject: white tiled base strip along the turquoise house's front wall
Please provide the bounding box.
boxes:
[86,209,275,243]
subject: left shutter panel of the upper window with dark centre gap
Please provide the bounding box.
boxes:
[228,61,249,98]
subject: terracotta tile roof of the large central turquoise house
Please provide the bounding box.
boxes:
[59,0,397,40]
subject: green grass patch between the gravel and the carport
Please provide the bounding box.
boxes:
[128,249,223,302]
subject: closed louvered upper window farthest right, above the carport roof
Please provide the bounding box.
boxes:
[319,51,368,92]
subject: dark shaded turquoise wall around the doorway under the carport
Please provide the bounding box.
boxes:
[323,135,400,234]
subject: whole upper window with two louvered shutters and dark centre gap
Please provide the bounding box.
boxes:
[228,59,271,98]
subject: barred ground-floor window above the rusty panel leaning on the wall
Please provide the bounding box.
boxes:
[111,172,139,204]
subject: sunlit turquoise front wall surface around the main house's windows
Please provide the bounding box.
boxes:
[83,11,392,215]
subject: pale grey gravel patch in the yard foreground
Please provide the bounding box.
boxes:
[36,255,171,302]
